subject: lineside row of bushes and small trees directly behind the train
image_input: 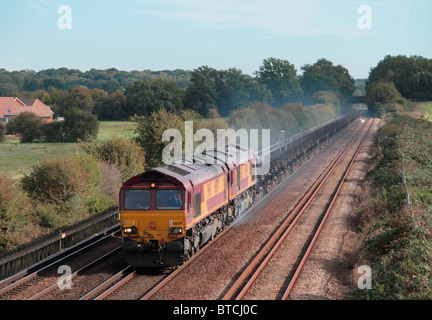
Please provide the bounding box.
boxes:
[133,99,340,167]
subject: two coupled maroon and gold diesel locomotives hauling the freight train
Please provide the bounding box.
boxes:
[120,145,258,268]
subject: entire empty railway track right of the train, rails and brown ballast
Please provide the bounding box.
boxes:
[222,120,373,300]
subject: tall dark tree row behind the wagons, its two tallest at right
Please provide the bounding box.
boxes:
[180,58,355,116]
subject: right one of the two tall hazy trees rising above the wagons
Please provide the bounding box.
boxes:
[300,59,355,98]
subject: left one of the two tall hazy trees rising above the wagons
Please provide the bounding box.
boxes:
[255,58,303,106]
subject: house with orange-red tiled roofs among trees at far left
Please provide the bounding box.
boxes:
[0,97,54,124]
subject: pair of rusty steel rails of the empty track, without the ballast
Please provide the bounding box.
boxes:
[222,120,373,300]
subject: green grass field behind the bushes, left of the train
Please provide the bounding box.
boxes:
[0,121,135,179]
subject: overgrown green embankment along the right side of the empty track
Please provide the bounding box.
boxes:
[354,113,432,300]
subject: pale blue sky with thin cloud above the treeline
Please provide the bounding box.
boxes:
[0,0,432,78]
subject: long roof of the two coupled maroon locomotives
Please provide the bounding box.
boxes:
[123,145,254,187]
